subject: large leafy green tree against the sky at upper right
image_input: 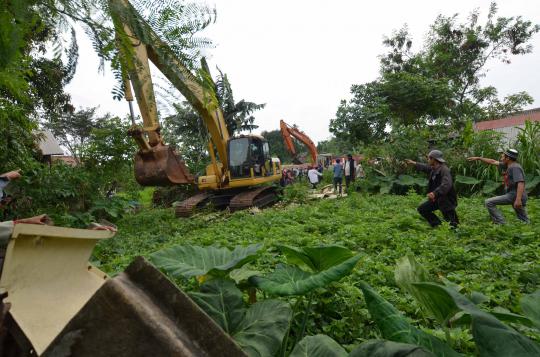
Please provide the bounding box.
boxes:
[330,3,540,143]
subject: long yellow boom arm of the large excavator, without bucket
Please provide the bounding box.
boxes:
[109,0,229,171]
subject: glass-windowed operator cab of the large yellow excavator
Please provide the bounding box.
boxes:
[227,135,272,178]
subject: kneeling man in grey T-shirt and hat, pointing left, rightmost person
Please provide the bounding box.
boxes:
[467,149,529,224]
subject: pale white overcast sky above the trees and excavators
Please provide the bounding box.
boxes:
[67,0,540,142]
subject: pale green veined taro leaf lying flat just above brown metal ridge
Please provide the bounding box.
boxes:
[150,244,262,278]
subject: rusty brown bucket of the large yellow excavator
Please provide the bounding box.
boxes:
[135,144,195,186]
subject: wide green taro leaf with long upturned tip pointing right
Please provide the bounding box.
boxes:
[253,255,360,296]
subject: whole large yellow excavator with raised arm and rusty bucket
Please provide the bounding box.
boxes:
[110,0,281,217]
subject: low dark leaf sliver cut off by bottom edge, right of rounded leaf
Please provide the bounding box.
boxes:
[349,340,435,357]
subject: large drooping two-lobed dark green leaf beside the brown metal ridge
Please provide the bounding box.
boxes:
[190,279,292,356]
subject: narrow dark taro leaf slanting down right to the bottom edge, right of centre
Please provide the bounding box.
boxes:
[360,282,460,357]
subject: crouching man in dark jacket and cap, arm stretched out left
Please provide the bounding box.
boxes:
[405,150,459,228]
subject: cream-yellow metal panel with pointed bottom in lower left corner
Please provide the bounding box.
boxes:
[0,224,114,355]
